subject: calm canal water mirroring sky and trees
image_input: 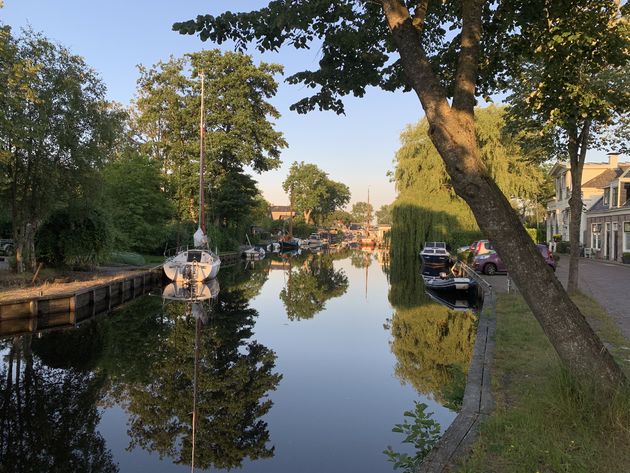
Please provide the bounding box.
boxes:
[0,251,476,473]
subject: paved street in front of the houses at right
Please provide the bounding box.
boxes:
[556,255,630,340]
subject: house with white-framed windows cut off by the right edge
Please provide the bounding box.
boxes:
[585,159,630,261]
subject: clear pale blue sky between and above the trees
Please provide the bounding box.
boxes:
[0,0,606,208]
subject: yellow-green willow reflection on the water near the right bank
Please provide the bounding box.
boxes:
[389,232,476,407]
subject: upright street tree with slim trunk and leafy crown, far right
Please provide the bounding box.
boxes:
[509,0,630,293]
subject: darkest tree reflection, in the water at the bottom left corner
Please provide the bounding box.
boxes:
[0,332,118,473]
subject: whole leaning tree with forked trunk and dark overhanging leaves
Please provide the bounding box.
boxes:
[173,0,628,387]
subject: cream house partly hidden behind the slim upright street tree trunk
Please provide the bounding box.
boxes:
[546,153,630,246]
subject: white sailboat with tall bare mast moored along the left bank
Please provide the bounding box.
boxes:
[163,75,221,282]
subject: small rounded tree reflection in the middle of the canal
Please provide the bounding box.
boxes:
[280,253,348,320]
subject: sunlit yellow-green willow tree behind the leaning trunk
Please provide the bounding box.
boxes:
[392,106,544,253]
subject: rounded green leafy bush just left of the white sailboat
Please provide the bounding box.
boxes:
[103,151,174,253]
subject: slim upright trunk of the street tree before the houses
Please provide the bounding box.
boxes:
[567,121,591,294]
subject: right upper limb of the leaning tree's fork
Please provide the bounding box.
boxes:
[453,0,484,115]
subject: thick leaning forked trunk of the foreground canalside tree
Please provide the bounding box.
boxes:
[381,0,625,387]
